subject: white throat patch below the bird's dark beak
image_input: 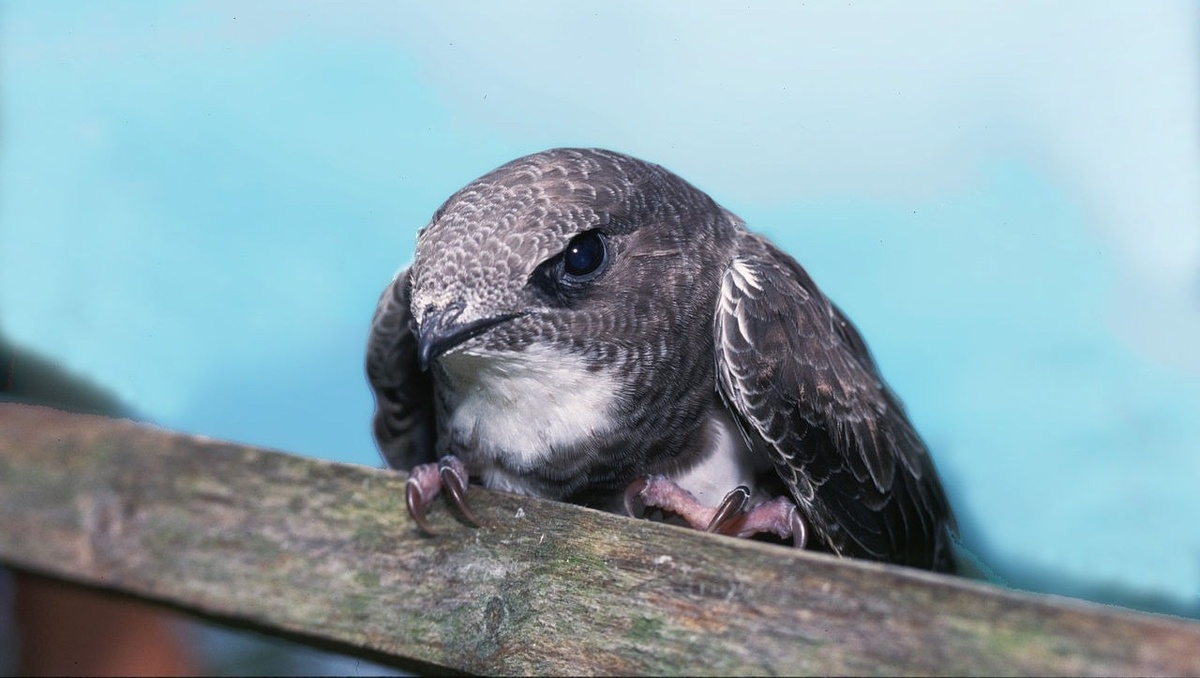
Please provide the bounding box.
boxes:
[440,344,618,469]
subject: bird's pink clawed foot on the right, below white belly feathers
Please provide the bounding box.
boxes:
[625,475,808,548]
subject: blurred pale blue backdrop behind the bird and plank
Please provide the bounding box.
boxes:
[0,0,1200,611]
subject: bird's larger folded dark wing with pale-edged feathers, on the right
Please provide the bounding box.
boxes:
[714,234,954,570]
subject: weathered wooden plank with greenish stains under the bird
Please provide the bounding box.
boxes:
[0,404,1200,674]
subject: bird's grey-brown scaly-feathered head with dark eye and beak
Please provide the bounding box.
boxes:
[412,144,739,367]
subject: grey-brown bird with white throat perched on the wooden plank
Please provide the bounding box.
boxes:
[366,148,958,572]
